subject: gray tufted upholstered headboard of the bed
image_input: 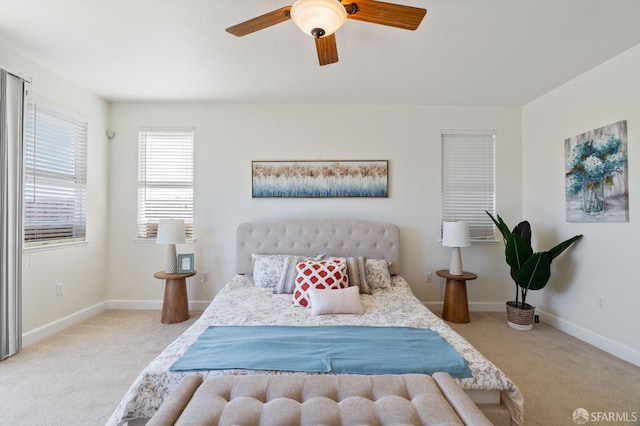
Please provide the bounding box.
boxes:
[236,218,400,274]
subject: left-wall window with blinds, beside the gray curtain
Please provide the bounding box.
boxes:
[24,101,87,247]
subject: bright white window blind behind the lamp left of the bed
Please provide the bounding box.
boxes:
[138,129,194,238]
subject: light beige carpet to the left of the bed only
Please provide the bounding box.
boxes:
[0,310,199,426]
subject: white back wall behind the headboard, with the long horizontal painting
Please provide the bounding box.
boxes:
[109,103,522,309]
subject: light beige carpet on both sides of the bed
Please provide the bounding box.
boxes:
[0,310,640,426]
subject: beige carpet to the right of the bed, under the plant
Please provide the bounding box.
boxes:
[449,312,640,426]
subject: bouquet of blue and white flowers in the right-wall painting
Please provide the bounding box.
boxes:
[566,135,626,194]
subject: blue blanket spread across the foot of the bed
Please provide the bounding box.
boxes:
[170,325,471,378]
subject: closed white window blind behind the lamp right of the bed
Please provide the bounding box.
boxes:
[442,130,496,242]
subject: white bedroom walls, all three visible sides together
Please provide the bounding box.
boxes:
[0,26,640,365]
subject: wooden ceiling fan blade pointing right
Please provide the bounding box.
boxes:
[344,0,427,30]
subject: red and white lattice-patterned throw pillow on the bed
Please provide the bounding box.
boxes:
[293,259,349,306]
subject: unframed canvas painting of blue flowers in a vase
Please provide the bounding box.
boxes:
[564,120,629,222]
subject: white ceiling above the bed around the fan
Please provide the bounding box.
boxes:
[0,0,640,105]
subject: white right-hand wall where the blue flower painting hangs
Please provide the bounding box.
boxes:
[524,45,640,365]
